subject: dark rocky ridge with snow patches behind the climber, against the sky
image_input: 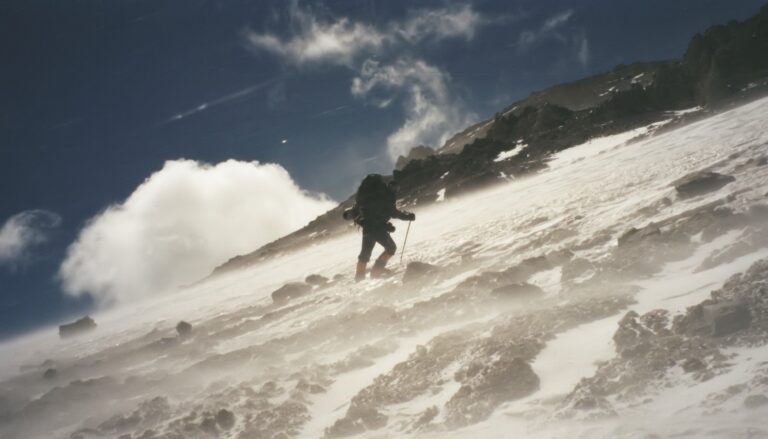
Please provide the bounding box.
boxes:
[214,5,768,273]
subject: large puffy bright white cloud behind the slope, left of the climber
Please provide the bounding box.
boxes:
[59,160,335,302]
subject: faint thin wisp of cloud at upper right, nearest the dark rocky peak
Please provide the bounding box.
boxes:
[516,9,590,67]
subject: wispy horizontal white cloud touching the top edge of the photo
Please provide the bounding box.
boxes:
[245,2,484,67]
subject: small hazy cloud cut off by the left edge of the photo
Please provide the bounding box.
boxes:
[0,209,61,268]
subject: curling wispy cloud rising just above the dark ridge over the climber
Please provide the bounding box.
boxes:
[352,59,471,160]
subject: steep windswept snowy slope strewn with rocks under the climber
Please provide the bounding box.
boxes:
[0,98,768,438]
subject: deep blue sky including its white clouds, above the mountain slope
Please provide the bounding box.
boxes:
[0,0,762,337]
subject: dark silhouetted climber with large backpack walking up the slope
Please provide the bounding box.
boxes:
[343,174,416,281]
